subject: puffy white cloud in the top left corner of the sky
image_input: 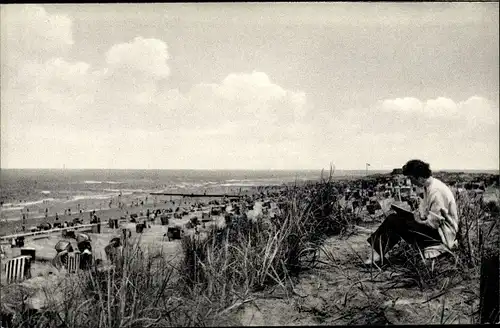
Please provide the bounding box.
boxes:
[1,5,73,65]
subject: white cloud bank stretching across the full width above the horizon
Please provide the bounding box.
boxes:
[1,6,498,169]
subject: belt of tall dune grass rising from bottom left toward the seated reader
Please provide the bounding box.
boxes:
[0,173,349,328]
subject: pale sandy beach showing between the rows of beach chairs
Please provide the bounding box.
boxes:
[1,190,240,288]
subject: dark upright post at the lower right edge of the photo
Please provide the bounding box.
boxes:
[479,224,500,324]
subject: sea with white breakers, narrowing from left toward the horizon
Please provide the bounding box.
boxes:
[0,169,380,218]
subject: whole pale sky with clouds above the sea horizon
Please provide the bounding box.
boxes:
[0,2,499,170]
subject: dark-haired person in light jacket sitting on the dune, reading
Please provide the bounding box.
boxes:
[365,160,459,264]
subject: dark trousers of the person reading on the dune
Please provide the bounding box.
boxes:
[367,213,441,257]
